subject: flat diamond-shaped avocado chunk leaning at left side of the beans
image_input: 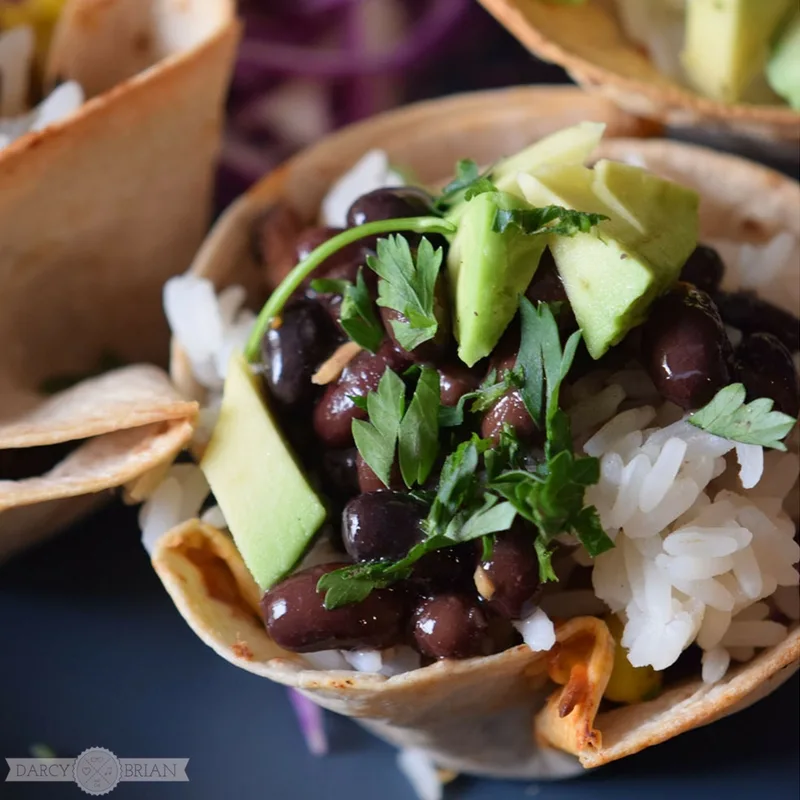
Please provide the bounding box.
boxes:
[200,354,325,589]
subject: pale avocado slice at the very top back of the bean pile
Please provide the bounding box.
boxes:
[492,122,606,197]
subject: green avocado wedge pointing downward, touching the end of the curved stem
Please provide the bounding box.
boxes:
[447,192,547,367]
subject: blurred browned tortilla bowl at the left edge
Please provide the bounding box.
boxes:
[0,0,238,558]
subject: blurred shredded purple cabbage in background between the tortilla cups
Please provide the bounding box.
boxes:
[218,0,564,208]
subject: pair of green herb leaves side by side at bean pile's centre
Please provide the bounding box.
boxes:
[352,367,440,489]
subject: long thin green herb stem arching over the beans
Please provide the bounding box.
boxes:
[244,217,456,363]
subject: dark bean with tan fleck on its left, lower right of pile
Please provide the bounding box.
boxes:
[475,521,540,619]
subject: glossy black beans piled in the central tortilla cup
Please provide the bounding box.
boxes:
[253,188,800,659]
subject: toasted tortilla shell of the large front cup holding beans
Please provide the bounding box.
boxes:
[153,89,800,778]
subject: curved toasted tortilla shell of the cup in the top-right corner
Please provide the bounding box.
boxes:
[480,0,800,145]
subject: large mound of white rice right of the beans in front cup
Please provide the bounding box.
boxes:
[584,394,800,682]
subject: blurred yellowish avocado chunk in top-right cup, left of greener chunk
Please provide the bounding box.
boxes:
[682,0,794,103]
